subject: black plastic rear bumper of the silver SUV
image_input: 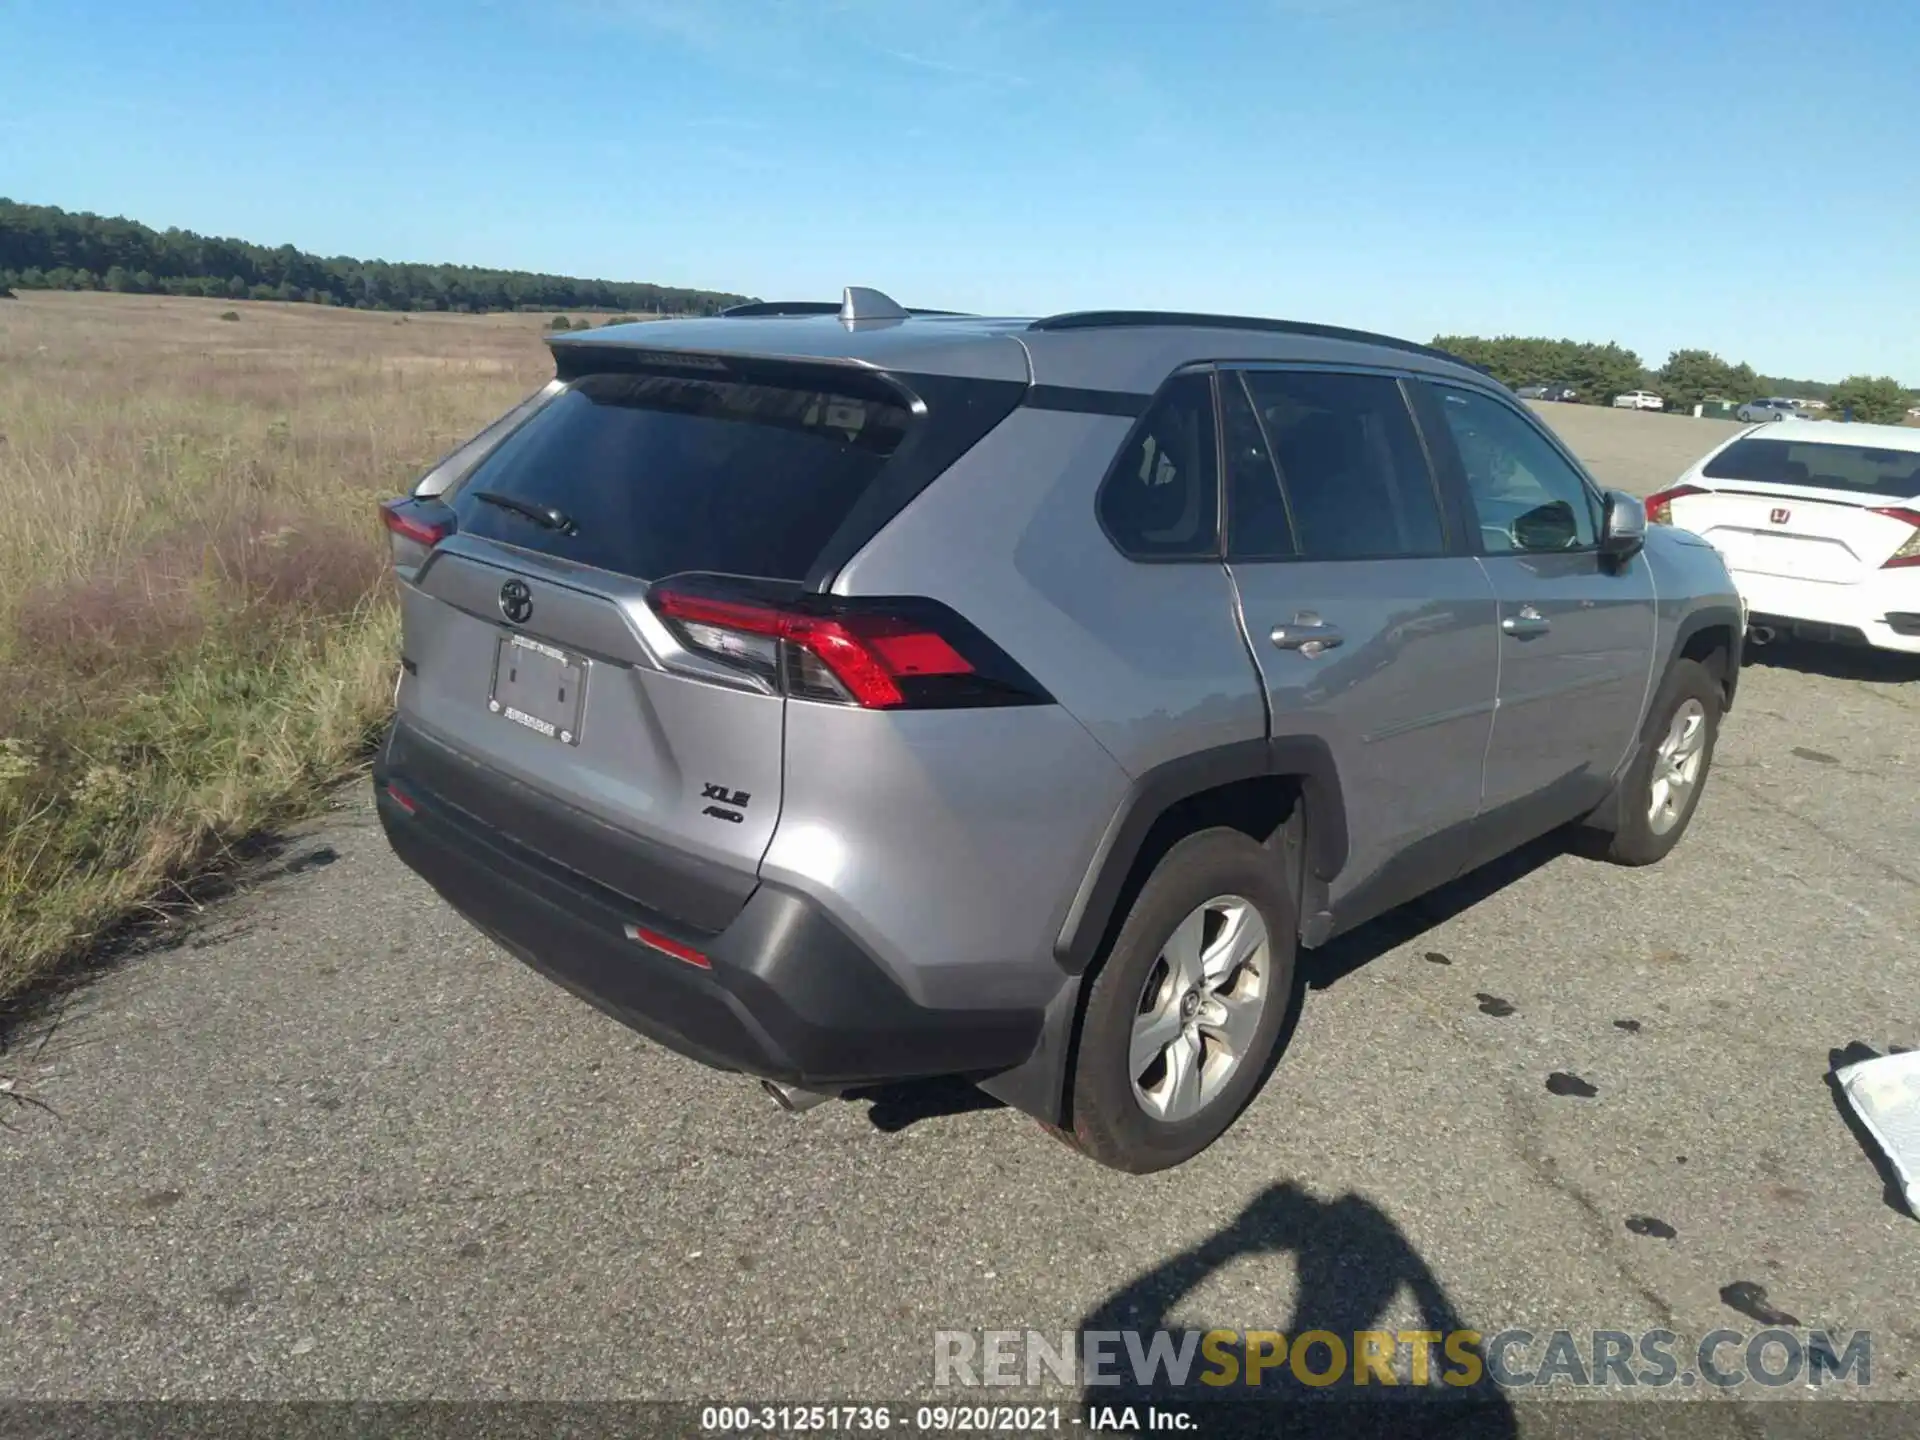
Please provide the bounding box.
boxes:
[374,725,1043,1091]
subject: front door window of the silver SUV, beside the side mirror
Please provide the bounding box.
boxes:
[1432,386,1597,555]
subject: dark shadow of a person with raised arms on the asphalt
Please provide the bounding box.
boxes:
[1081,1181,1519,1440]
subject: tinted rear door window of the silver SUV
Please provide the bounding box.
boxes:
[1244,371,1446,561]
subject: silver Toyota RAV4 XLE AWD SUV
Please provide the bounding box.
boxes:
[374,288,1743,1171]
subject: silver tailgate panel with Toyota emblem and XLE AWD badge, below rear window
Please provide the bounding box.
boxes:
[394,540,781,929]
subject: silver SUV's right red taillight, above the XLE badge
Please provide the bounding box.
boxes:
[647,576,1052,710]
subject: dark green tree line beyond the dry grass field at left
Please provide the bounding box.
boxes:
[0,200,749,315]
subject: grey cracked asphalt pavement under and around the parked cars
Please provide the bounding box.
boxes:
[0,407,1920,1400]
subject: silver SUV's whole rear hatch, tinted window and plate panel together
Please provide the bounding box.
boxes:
[386,348,1020,931]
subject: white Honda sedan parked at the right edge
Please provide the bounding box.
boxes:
[1647,419,1920,655]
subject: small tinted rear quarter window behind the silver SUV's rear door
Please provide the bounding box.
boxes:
[1098,374,1219,561]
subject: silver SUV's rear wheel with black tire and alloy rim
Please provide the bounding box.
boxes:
[1056,829,1298,1175]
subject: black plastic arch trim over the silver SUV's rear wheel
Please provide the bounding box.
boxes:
[1054,735,1348,975]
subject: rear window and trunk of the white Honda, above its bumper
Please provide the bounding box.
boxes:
[1649,436,1920,586]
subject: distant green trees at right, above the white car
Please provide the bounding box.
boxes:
[1432,334,1920,424]
